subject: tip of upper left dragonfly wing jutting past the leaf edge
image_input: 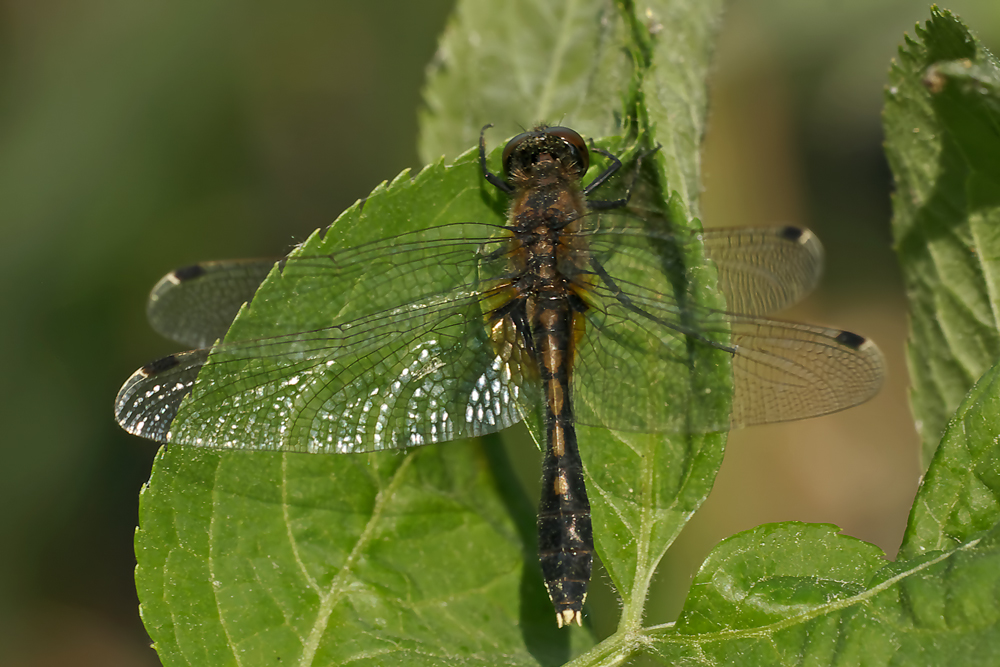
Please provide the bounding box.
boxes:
[146,258,278,348]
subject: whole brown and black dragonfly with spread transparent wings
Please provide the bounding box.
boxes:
[115,126,884,627]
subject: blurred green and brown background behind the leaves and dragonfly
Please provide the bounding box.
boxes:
[0,0,1000,666]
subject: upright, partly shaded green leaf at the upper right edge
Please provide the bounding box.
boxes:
[883,9,1000,461]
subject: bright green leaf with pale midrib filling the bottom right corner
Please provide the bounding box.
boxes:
[649,340,1000,665]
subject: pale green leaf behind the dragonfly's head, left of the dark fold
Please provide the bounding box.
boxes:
[420,0,635,162]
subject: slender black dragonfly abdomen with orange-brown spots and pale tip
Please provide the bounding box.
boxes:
[533,297,594,627]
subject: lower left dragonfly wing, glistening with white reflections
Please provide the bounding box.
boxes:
[119,295,535,453]
